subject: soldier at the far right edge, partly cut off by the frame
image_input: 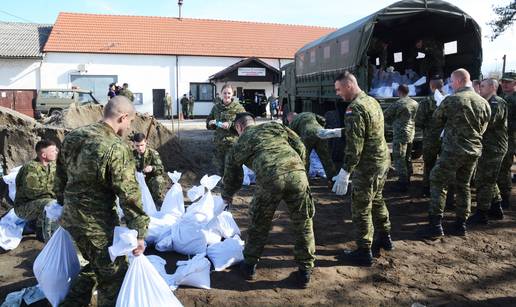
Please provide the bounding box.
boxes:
[497,72,516,209]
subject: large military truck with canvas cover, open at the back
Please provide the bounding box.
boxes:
[279,0,482,161]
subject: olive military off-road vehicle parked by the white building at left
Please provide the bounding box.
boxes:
[35,88,99,118]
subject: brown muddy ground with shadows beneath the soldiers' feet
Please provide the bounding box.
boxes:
[0,119,516,306]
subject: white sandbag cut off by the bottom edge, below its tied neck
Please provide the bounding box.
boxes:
[116,255,182,307]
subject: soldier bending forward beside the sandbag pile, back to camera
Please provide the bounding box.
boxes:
[222,113,315,288]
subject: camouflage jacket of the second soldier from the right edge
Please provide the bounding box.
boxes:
[482,95,507,153]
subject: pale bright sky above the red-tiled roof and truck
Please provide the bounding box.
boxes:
[0,0,516,76]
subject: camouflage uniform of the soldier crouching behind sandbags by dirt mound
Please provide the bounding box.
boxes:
[133,147,165,208]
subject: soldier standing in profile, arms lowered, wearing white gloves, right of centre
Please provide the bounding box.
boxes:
[320,71,393,266]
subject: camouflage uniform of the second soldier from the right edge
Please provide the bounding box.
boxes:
[475,95,507,211]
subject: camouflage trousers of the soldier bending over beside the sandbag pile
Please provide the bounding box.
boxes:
[244,171,315,269]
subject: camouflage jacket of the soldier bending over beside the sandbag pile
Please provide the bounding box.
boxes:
[222,122,306,197]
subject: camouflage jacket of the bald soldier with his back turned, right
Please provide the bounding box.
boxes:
[433,87,491,157]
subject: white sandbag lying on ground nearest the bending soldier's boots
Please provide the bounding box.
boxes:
[206,236,244,271]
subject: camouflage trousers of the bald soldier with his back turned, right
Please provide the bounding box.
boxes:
[428,151,478,220]
